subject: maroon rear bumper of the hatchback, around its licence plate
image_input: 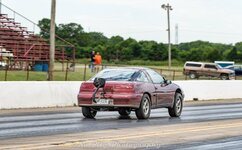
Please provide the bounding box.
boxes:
[78,93,142,108]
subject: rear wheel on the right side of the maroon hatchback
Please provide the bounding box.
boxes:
[135,94,151,119]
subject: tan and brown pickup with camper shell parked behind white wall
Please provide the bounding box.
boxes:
[183,61,235,80]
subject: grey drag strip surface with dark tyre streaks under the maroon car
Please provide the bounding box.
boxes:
[0,100,242,150]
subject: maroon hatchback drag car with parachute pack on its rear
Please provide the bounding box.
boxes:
[78,67,184,119]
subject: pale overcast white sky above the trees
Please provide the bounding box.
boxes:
[2,0,242,44]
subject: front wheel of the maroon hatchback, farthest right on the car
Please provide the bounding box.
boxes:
[168,93,183,117]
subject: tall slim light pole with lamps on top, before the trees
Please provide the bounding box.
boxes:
[161,4,172,70]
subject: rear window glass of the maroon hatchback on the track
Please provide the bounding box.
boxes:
[91,69,137,81]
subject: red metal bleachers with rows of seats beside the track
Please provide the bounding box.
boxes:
[0,2,75,69]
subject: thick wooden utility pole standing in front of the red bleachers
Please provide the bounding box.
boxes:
[48,0,56,81]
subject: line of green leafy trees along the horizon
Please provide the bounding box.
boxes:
[38,18,242,62]
